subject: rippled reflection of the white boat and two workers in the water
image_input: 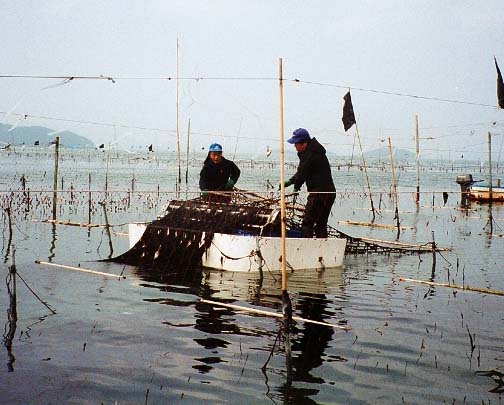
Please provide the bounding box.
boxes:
[133,267,346,403]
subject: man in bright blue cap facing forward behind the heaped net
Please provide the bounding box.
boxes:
[199,143,240,195]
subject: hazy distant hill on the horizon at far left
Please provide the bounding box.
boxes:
[0,124,94,148]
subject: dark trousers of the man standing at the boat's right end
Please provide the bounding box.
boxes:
[301,193,336,238]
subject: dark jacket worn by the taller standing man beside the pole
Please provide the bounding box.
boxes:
[290,138,336,191]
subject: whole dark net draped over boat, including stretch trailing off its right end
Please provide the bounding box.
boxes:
[110,191,435,268]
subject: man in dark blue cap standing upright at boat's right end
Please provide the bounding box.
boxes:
[284,128,336,238]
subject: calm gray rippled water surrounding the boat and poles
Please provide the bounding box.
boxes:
[0,151,504,404]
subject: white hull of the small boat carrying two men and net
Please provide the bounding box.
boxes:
[129,223,346,272]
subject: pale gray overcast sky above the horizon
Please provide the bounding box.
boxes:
[0,0,504,160]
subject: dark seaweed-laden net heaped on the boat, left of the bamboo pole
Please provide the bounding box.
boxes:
[110,193,290,267]
